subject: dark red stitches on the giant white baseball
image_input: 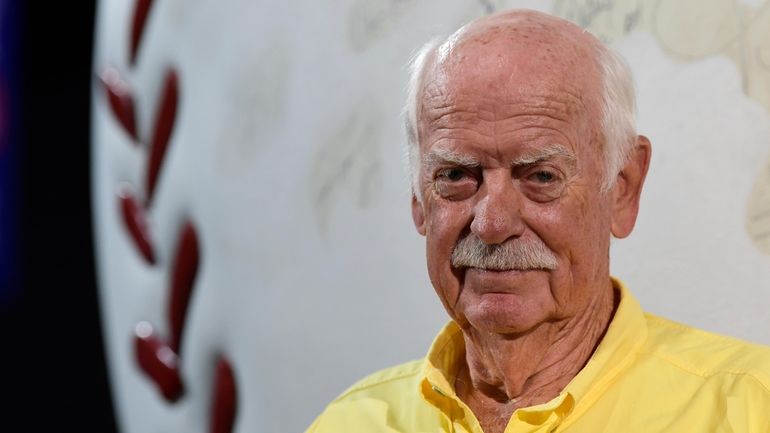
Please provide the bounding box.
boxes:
[101,0,237,426]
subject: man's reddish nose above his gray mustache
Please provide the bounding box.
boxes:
[464,173,525,245]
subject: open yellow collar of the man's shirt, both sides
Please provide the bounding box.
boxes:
[420,277,647,424]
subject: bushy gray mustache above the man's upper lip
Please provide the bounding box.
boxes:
[452,234,558,271]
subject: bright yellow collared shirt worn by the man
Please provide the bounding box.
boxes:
[307,280,770,433]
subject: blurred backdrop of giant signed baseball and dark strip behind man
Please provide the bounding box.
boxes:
[0,0,770,433]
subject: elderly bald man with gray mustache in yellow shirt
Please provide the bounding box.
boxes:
[309,11,770,433]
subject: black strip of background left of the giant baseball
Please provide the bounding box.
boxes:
[0,0,116,432]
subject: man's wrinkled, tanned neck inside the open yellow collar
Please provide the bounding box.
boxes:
[455,284,617,433]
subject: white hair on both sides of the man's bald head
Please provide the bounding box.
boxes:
[402,32,636,202]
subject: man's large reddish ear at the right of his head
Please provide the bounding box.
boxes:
[611,135,652,238]
